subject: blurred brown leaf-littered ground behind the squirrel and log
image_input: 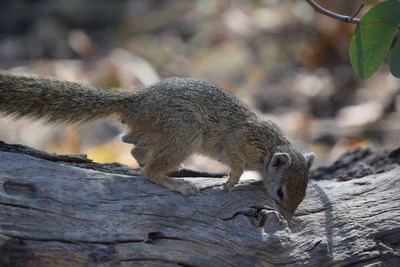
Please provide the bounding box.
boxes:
[0,0,400,170]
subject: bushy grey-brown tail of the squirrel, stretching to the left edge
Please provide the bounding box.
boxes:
[0,73,127,123]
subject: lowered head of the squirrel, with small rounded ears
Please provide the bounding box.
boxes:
[263,149,315,220]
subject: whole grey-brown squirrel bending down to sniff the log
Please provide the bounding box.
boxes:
[0,72,315,218]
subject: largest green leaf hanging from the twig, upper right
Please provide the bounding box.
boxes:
[350,0,400,78]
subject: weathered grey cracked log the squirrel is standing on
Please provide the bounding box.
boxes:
[0,141,400,266]
